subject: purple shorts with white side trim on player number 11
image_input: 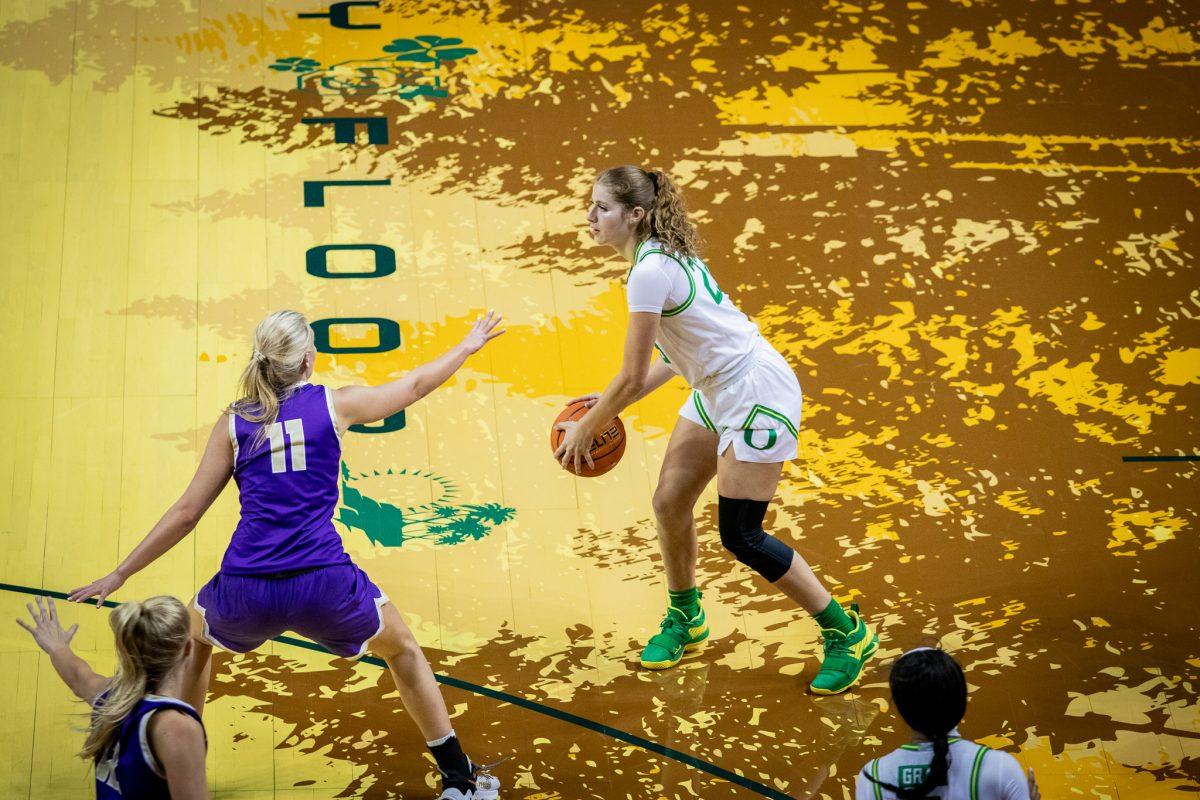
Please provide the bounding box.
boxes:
[196,564,388,658]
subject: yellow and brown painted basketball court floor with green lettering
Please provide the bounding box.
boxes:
[0,0,1200,800]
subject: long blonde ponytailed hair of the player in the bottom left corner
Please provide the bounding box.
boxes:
[79,596,192,760]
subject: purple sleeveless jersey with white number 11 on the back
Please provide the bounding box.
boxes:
[221,384,350,575]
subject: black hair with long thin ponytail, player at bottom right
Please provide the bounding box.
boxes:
[863,649,967,800]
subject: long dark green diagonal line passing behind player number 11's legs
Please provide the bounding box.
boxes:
[0,583,792,800]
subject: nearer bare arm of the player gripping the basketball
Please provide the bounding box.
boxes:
[554,312,665,471]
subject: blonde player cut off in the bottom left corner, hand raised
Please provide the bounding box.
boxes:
[17,596,209,800]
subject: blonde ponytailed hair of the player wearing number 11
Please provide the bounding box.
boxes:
[226,311,312,450]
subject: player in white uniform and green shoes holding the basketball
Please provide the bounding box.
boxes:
[556,166,878,694]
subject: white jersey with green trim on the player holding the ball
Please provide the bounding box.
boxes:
[625,239,766,389]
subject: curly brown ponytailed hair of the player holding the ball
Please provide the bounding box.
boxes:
[596,164,701,259]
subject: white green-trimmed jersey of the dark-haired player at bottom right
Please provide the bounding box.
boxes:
[854,732,1030,800]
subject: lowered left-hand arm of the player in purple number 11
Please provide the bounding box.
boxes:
[71,411,233,606]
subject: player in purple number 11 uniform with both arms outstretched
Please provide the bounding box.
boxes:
[71,311,504,800]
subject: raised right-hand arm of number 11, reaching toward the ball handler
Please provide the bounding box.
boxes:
[334,311,504,428]
